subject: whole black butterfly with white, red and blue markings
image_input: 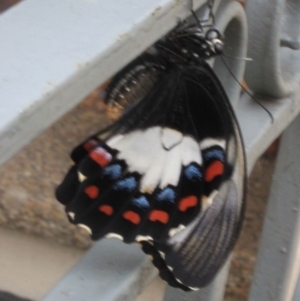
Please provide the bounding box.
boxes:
[56,10,246,290]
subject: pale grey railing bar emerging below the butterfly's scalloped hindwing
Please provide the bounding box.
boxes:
[43,238,157,301]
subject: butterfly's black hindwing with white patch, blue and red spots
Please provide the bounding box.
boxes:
[56,63,202,242]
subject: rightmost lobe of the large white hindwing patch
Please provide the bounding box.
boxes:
[182,136,202,166]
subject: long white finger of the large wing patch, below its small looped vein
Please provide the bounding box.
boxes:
[159,144,182,189]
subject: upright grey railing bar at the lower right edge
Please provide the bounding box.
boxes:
[249,115,300,301]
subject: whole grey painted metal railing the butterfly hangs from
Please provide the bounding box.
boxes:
[0,0,300,301]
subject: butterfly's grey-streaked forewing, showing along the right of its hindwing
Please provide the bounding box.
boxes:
[148,66,246,289]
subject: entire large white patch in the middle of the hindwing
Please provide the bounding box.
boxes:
[107,126,202,194]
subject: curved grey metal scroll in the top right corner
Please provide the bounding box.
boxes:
[245,0,300,98]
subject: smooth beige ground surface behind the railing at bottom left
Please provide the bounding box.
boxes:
[0,228,166,301]
